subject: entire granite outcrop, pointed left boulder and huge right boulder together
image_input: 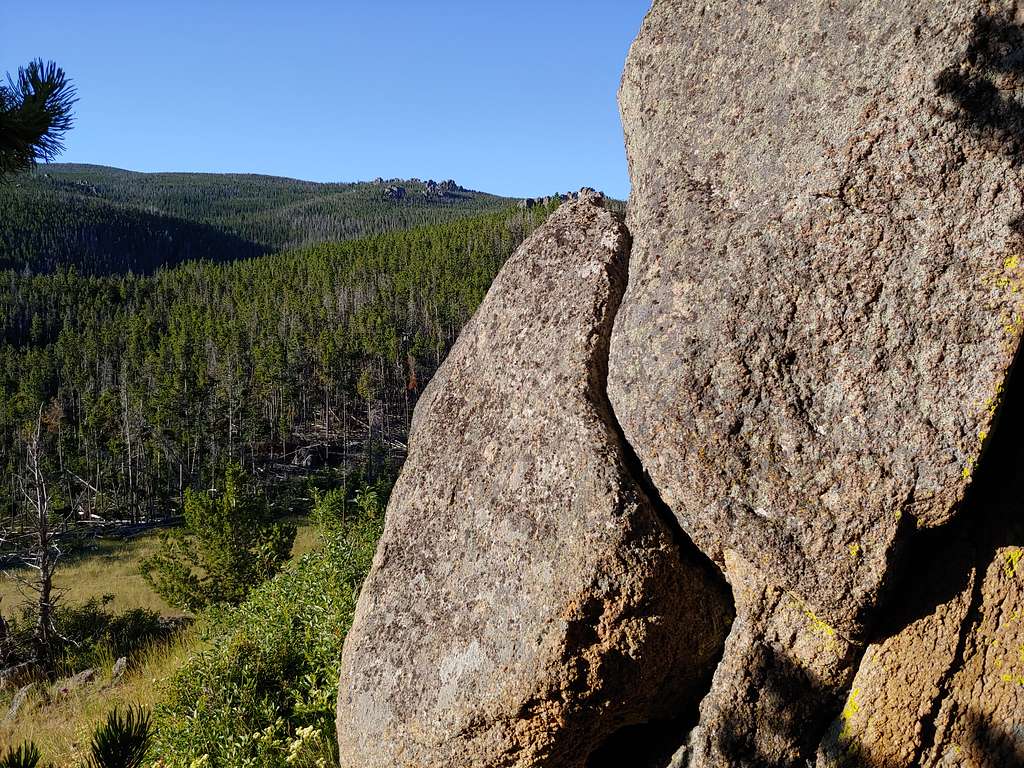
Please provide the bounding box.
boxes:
[339,0,1024,768]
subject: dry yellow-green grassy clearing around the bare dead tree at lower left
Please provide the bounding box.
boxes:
[0,517,322,766]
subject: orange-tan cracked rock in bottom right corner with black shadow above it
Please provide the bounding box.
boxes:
[818,321,1024,768]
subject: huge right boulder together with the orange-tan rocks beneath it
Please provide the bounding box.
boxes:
[608,0,1024,768]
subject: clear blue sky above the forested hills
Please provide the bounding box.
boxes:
[0,0,649,197]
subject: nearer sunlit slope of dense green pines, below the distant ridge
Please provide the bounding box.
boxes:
[0,199,557,519]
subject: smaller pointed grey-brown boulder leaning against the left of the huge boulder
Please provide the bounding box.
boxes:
[338,196,730,768]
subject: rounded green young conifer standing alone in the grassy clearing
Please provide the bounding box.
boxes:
[142,465,295,611]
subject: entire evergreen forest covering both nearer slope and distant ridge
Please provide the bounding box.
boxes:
[0,166,556,527]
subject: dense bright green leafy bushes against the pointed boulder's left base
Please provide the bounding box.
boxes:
[156,492,382,768]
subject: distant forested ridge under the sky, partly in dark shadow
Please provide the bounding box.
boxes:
[0,164,510,274]
